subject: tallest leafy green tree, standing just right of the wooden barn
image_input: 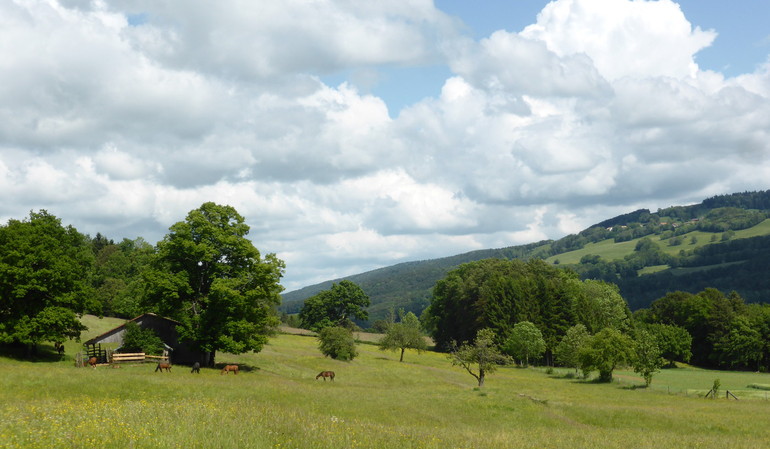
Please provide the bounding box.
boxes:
[145,202,285,365]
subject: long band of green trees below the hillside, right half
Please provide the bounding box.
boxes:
[422,259,770,382]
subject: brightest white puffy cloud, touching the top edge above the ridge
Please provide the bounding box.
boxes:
[521,0,716,81]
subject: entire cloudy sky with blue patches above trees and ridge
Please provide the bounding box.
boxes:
[0,0,770,291]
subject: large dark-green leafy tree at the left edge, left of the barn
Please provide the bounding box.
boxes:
[0,210,98,354]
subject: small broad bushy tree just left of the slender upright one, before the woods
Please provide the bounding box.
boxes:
[578,328,634,382]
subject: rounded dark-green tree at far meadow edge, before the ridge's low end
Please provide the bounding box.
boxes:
[299,280,370,331]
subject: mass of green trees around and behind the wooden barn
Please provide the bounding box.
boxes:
[0,202,285,365]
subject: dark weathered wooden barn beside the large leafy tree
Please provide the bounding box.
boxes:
[85,313,208,365]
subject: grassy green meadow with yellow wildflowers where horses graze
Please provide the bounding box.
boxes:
[0,321,770,449]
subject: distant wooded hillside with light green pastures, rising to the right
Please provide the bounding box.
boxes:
[280,190,770,320]
